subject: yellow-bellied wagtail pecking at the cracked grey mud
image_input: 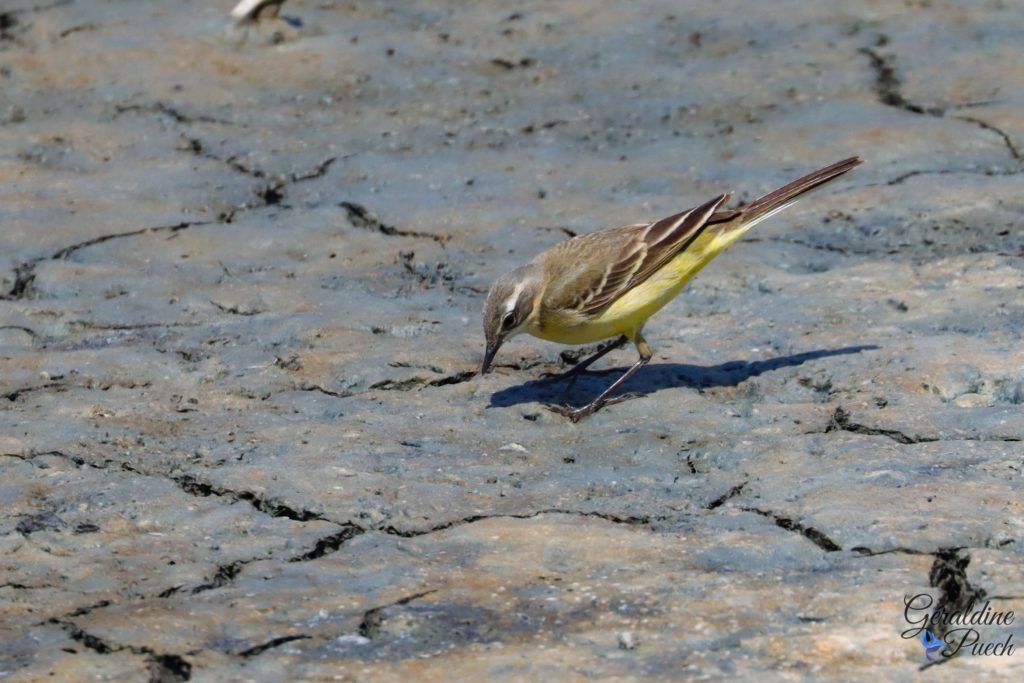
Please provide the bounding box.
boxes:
[480,157,862,422]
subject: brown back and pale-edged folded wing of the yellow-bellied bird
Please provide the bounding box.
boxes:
[543,195,729,317]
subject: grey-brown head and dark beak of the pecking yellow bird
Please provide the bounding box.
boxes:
[480,264,541,374]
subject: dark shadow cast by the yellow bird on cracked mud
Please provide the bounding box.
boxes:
[488,344,879,408]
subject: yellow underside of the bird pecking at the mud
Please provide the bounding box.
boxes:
[526,226,746,344]
